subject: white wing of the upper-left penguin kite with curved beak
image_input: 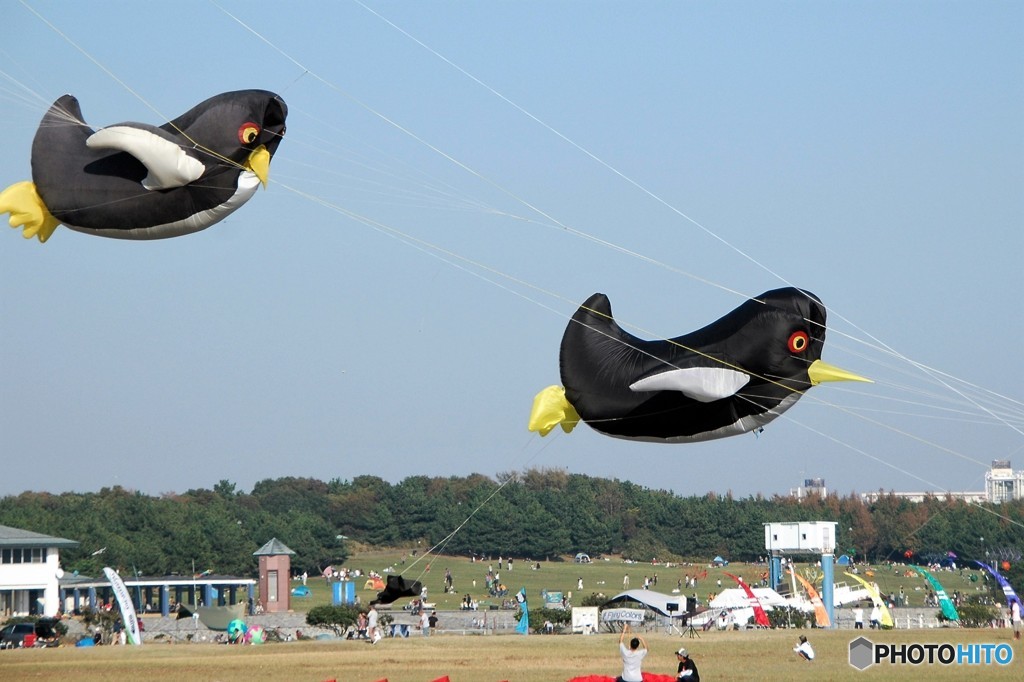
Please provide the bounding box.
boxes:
[85,126,206,189]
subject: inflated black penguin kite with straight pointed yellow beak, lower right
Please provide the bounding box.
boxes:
[529,288,870,442]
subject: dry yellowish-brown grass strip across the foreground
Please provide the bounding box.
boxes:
[0,630,1024,682]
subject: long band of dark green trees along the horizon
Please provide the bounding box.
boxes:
[0,469,1024,576]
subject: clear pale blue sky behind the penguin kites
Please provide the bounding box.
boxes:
[0,0,1024,496]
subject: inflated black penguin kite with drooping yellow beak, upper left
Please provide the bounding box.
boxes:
[0,90,288,242]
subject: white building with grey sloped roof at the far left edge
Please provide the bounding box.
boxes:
[0,525,78,620]
